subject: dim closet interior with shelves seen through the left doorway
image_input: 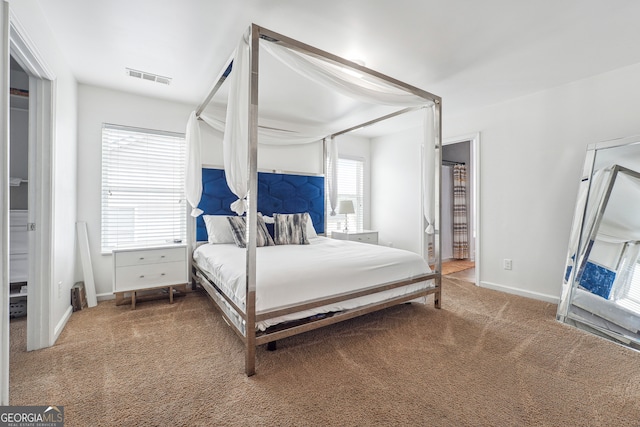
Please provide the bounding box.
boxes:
[9,58,29,318]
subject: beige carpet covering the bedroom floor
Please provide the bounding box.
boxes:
[10,278,640,426]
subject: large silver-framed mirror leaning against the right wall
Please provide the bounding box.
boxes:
[557,137,640,350]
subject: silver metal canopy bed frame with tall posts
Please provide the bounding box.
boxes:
[192,24,442,376]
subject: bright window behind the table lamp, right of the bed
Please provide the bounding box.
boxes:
[326,157,364,236]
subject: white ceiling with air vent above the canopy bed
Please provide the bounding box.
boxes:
[33,0,640,130]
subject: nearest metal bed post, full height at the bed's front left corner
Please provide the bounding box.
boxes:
[245,25,260,376]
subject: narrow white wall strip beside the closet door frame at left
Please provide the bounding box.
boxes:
[10,0,77,344]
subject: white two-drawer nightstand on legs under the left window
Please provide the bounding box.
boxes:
[113,245,189,309]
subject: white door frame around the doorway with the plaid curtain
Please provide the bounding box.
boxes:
[440,132,482,286]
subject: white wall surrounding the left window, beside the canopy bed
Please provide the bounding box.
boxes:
[76,81,194,297]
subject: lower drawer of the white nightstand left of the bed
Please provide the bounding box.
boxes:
[114,261,187,292]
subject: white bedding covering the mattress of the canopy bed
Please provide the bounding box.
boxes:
[193,237,434,330]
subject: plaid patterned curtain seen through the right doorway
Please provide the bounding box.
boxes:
[453,165,469,259]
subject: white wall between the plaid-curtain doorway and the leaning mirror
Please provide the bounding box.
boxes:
[443,64,640,301]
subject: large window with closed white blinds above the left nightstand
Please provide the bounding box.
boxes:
[102,124,187,253]
